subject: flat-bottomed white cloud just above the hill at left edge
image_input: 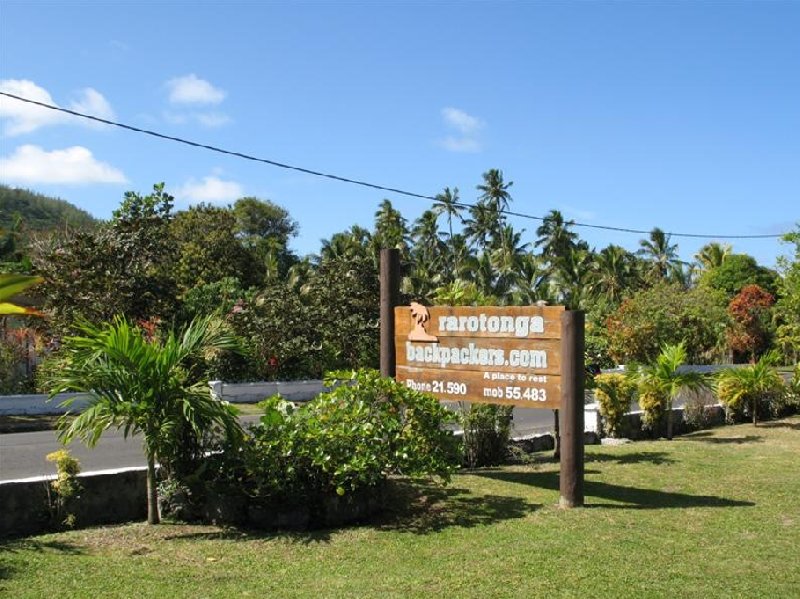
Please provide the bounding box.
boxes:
[0,145,127,185]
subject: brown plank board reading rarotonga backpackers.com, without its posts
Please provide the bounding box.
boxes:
[394,303,564,409]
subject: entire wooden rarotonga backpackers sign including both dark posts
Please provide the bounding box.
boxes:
[381,250,584,508]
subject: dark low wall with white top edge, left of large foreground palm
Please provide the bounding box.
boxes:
[0,468,147,538]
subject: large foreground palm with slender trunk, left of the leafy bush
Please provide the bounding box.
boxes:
[49,317,242,524]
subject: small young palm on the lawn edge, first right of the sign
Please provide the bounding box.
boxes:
[632,342,707,440]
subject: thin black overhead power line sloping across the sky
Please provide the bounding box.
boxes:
[0,91,783,239]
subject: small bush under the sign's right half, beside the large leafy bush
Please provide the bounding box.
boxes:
[461,404,514,468]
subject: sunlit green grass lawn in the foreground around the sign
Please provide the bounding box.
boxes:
[0,417,800,599]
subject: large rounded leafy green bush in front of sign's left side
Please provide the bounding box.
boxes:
[215,370,458,506]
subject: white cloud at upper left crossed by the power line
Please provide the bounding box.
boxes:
[0,79,114,136]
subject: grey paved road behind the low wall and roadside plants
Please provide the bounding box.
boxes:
[0,408,553,480]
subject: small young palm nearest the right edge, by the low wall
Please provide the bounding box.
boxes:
[716,351,783,426]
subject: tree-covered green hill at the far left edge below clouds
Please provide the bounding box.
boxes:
[0,185,97,231]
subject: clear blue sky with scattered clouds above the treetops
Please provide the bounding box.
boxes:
[0,0,800,265]
